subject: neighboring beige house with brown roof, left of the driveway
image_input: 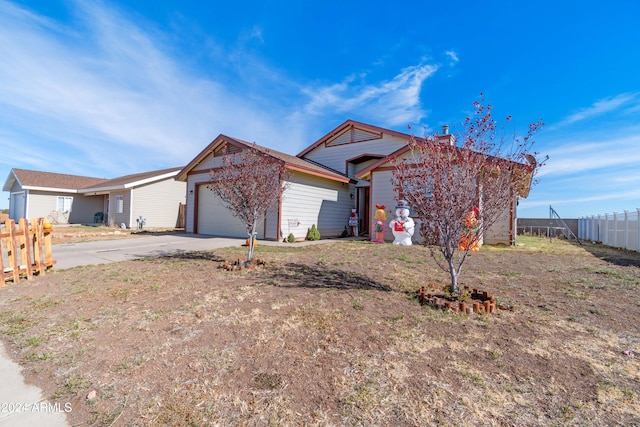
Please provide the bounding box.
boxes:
[3,168,185,228]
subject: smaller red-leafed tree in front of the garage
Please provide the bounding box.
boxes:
[208,145,287,261]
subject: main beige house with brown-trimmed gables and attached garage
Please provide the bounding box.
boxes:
[176,120,526,244]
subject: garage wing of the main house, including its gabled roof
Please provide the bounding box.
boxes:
[176,135,353,240]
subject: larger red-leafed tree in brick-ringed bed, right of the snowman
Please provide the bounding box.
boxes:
[392,101,543,294]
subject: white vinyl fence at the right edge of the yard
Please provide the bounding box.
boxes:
[578,208,640,251]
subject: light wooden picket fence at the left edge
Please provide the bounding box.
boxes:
[0,218,56,287]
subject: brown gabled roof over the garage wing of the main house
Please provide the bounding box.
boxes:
[176,134,351,182]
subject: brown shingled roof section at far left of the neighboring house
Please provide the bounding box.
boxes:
[2,168,106,193]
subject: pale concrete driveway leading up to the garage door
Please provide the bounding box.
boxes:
[53,234,249,270]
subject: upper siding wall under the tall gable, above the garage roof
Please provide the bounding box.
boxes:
[303,135,407,177]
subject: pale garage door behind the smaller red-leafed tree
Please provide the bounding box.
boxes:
[197,185,264,239]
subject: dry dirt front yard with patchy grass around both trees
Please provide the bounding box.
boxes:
[0,232,640,426]
